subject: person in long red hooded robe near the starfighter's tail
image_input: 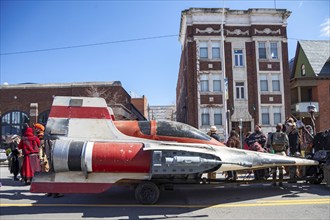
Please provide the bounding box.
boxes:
[18,127,41,185]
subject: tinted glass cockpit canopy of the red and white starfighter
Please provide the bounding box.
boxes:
[139,121,211,141]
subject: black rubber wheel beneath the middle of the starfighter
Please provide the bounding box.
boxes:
[135,181,160,205]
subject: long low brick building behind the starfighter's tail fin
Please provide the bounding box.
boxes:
[0,81,146,141]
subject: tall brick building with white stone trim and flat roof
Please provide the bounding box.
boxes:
[176,8,291,139]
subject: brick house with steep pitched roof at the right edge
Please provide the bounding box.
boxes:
[290,40,330,131]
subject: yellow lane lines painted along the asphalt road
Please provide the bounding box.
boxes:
[0,197,330,208]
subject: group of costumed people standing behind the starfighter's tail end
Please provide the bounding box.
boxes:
[8,123,63,198]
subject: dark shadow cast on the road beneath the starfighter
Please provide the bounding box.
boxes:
[0,168,330,219]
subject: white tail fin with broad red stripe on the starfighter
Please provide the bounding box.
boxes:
[46,96,122,139]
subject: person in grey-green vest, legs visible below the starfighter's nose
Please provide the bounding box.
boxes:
[269,123,289,187]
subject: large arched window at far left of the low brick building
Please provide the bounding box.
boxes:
[0,111,30,138]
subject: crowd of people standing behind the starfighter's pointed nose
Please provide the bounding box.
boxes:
[209,117,314,186]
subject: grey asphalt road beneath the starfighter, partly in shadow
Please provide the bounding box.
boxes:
[0,164,330,220]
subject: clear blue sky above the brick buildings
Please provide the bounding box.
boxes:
[0,0,330,105]
